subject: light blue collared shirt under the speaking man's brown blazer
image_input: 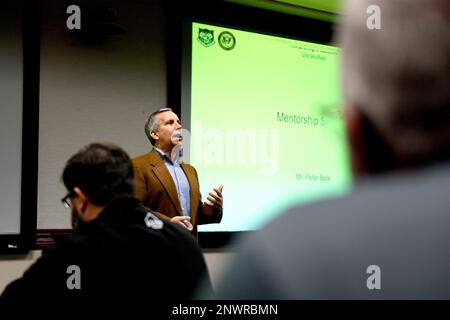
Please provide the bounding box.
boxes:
[153,147,191,216]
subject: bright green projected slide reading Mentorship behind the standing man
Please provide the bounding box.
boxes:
[188,22,352,231]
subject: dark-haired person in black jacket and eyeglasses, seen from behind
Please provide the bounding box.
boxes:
[0,143,211,312]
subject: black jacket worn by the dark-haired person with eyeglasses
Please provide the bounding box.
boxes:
[0,198,211,310]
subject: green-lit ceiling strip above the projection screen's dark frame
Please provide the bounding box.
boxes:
[225,0,342,22]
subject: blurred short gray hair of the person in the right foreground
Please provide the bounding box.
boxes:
[337,0,450,160]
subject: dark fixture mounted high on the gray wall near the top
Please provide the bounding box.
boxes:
[72,0,125,45]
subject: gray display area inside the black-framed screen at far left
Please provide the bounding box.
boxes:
[0,0,23,234]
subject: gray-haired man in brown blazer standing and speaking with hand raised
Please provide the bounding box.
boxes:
[133,108,223,236]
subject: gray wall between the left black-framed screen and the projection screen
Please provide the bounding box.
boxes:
[37,0,166,228]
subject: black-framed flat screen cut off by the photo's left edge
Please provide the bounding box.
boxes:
[0,0,40,254]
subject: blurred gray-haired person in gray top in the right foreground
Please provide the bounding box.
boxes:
[216,0,450,299]
